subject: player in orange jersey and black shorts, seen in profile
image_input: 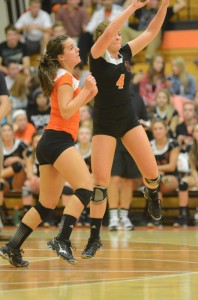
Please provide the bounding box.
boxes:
[0,35,97,267]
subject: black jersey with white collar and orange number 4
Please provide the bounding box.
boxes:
[89,44,132,110]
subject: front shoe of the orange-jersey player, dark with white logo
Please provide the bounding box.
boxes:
[47,238,77,264]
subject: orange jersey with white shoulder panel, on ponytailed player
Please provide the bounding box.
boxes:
[45,69,80,140]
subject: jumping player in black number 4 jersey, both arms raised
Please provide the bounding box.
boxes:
[81,0,169,258]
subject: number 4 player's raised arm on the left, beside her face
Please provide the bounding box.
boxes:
[91,0,149,58]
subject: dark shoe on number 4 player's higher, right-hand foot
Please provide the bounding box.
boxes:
[143,186,162,221]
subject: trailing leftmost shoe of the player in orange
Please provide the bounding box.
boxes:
[0,245,29,267]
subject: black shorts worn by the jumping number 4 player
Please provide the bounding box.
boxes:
[93,106,140,138]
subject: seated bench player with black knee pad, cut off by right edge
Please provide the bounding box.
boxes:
[174,124,198,227]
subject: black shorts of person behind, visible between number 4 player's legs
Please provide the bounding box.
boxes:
[111,151,142,179]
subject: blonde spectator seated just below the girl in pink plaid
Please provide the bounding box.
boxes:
[152,90,179,137]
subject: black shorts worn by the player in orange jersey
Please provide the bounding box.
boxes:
[36,129,74,165]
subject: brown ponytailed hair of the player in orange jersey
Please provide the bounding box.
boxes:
[38,35,69,97]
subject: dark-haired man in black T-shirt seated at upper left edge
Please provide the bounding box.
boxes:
[0,25,30,75]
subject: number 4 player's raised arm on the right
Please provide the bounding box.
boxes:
[128,0,169,56]
